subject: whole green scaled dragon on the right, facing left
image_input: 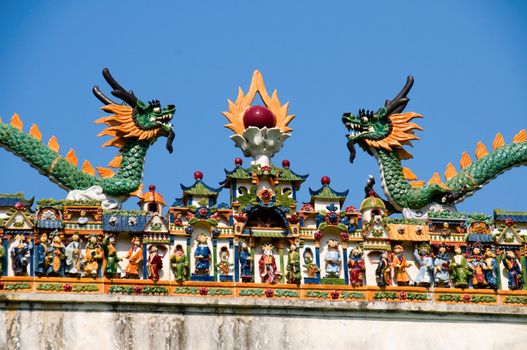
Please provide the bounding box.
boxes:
[342,76,527,217]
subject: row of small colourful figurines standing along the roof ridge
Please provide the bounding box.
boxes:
[0,232,524,290]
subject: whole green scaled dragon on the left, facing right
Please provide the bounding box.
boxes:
[0,68,176,207]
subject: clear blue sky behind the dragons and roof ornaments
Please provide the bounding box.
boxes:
[0,0,527,214]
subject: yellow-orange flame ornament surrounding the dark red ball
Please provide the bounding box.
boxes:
[222,70,295,134]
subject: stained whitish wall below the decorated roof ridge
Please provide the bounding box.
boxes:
[0,293,527,350]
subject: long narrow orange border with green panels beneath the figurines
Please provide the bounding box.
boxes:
[0,276,527,306]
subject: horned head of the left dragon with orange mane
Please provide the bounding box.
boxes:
[93,68,176,153]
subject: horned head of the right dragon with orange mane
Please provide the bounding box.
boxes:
[342,76,422,163]
